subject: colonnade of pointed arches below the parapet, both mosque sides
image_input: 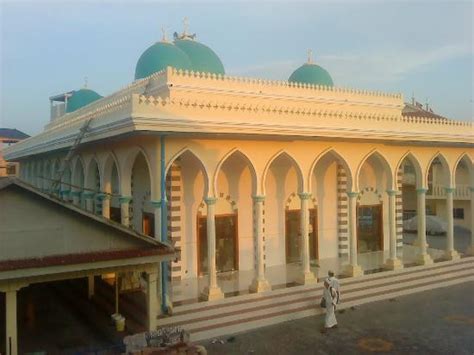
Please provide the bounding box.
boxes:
[21,140,474,299]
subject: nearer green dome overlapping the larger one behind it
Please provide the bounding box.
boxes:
[135,42,191,80]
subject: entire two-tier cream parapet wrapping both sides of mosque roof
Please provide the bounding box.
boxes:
[1,67,473,159]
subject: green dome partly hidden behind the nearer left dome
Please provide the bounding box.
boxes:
[174,39,225,74]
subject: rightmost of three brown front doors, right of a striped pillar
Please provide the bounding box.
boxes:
[357,204,383,253]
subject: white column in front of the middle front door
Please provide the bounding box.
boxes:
[296,192,317,285]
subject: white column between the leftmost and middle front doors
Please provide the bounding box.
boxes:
[250,196,272,292]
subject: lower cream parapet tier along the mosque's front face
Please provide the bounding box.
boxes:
[133,95,473,143]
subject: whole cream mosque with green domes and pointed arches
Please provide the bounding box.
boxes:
[4,18,474,348]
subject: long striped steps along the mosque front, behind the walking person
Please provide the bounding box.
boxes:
[159,258,474,341]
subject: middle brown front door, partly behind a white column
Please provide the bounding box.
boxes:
[285,208,318,264]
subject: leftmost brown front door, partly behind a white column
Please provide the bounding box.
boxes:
[198,214,238,275]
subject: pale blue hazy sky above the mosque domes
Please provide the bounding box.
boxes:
[0,0,474,135]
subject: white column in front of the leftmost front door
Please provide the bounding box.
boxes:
[203,197,224,301]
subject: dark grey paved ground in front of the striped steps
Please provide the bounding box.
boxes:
[202,282,474,355]
